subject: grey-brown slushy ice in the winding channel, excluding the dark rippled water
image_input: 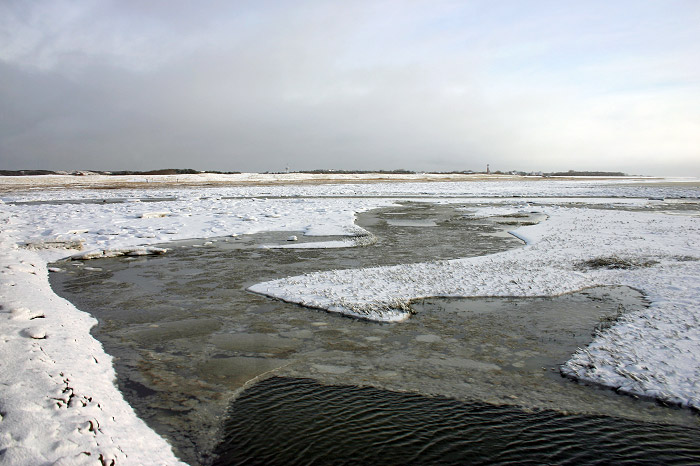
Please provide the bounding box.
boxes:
[46,203,697,463]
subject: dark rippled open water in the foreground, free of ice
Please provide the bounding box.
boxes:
[215,377,700,465]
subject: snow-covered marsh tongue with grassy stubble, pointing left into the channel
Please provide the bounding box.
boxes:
[250,206,700,409]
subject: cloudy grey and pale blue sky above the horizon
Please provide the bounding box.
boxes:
[0,0,700,176]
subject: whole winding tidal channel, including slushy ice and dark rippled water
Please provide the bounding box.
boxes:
[51,203,700,464]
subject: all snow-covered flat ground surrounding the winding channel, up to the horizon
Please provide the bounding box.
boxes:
[0,173,700,464]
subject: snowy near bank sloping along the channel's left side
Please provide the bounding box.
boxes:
[0,246,187,465]
